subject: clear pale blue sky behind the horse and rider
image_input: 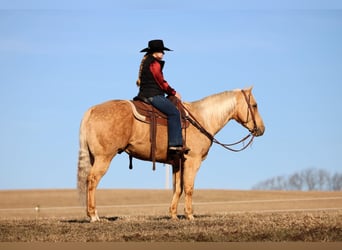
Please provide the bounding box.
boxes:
[0,0,342,189]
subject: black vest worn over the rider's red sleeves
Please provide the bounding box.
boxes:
[138,55,165,98]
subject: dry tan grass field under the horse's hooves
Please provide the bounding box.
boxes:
[0,190,342,242]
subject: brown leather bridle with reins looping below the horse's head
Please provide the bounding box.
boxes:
[181,89,258,152]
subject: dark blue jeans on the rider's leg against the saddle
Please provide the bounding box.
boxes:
[148,95,183,147]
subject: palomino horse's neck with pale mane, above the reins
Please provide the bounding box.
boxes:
[191,91,236,135]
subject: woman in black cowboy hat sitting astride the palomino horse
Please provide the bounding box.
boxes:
[137,40,189,153]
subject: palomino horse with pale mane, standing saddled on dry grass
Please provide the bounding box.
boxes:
[78,88,265,222]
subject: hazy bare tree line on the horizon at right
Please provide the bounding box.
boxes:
[252,168,342,191]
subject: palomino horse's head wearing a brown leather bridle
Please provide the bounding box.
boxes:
[235,87,265,136]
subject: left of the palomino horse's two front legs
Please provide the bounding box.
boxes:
[170,164,183,219]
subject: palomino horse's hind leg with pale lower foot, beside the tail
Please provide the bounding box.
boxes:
[87,156,111,222]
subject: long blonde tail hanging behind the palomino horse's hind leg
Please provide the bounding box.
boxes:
[77,111,92,205]
